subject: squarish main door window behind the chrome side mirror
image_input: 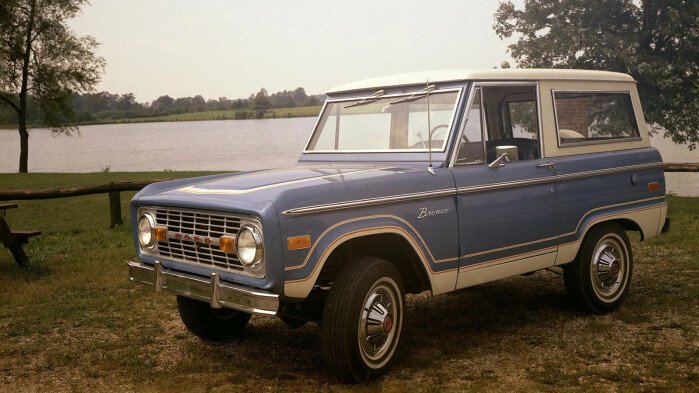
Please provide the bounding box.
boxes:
[483,85,541,162]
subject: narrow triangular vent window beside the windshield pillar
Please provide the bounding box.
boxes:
[454,87,485,165]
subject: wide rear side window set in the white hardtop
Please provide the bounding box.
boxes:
[553,91,639,146]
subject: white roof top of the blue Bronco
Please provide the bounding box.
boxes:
[328,68,634,94]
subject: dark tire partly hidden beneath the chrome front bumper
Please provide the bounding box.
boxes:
[177,296,250,341]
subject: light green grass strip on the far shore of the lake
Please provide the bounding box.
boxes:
[0,105,321,130]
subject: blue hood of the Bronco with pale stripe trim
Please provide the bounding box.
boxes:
[134,163,454,212]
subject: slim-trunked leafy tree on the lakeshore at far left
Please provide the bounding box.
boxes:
[0,0,105,172]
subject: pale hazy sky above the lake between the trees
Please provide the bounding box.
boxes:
[69,0,522,102]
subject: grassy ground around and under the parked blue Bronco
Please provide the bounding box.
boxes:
[0,172,699,392]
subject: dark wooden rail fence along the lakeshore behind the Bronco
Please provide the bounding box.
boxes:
[0,163,699,227]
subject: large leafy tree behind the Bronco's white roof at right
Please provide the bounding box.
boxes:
[493,0,699,150]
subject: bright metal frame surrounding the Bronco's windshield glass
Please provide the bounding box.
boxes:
[303,86,464,154]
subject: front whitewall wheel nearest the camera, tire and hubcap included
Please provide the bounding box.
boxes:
[321,258,404,383]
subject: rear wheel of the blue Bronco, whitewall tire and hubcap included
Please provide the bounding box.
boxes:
[563,223,633,314]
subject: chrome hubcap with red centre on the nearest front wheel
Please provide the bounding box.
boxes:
[359,284,400,361]
